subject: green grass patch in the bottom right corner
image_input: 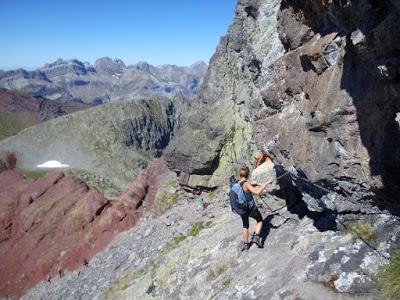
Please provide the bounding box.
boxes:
[377,251,400,299]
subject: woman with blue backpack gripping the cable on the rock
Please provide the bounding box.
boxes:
[229,166,271,251]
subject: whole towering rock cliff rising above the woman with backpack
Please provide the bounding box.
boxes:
[167,1,400,210]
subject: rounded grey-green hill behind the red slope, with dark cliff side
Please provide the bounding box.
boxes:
[0,98,175,196]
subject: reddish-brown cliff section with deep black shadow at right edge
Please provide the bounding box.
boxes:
[251,1,400,208]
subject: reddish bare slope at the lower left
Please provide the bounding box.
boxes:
[0,160,170,297]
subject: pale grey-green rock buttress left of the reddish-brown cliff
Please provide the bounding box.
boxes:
[165,1,284,187]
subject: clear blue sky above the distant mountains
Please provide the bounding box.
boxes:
[0,0,237,69]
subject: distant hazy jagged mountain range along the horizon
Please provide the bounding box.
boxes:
[0,57,207,104]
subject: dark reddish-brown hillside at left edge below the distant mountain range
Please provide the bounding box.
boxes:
[0,89,89,139]
